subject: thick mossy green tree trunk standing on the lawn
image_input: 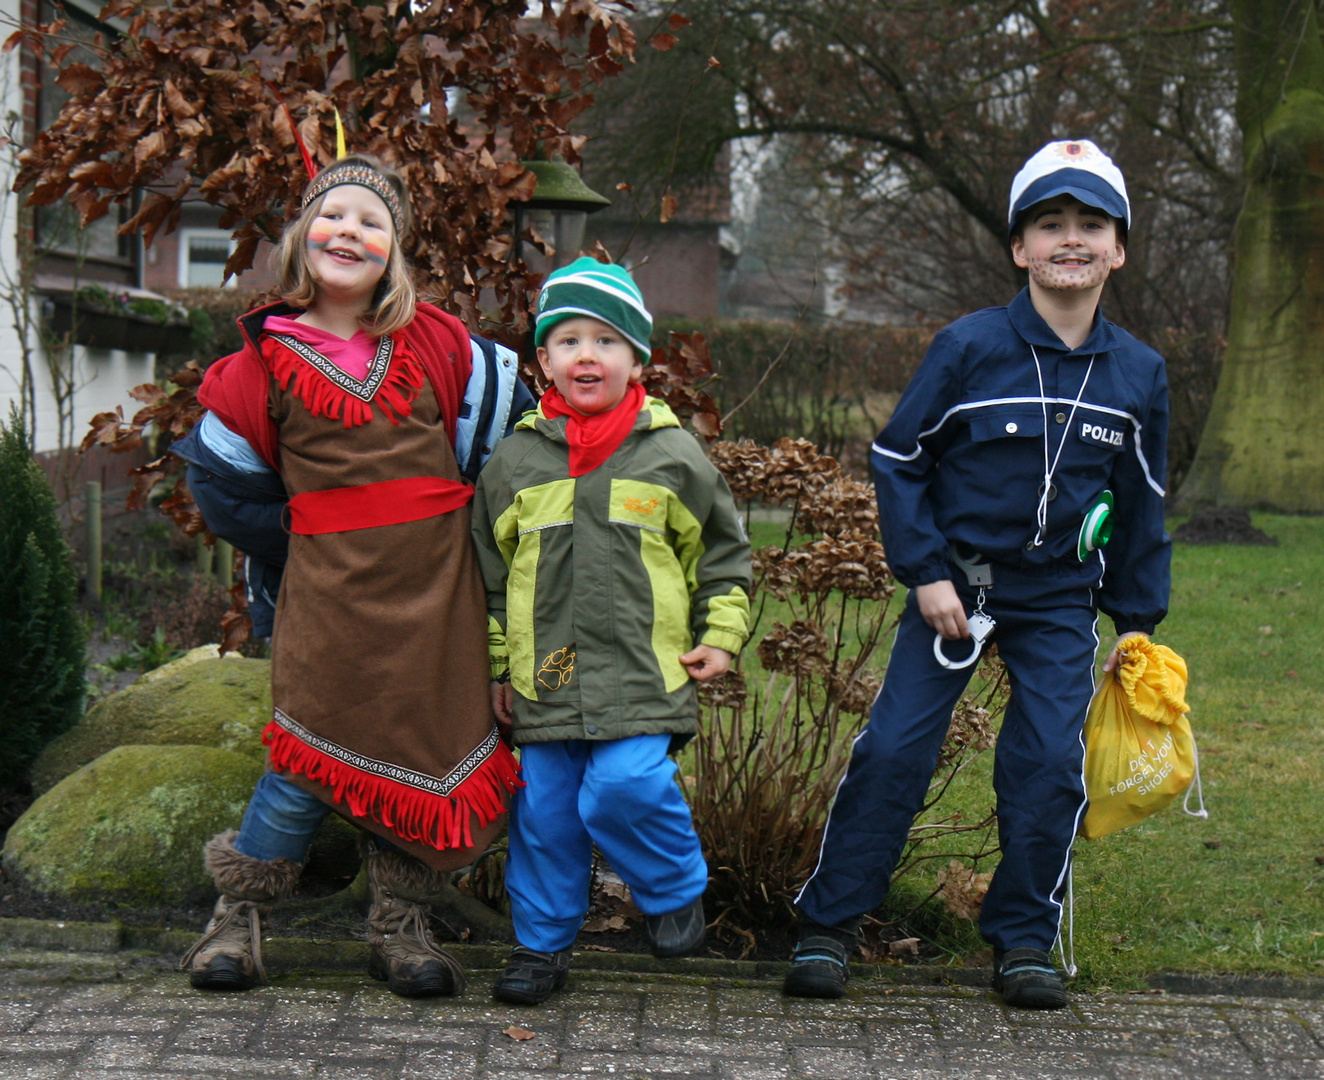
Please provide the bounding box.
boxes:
[1186,0,1324,512]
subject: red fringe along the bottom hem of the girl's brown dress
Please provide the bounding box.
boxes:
[262,720,524,851]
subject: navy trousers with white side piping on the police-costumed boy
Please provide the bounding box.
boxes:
[796,572,1099,952]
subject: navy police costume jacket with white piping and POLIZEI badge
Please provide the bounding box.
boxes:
[870,290,1172,633]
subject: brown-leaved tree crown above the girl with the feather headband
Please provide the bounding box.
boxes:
[7,0,634,330]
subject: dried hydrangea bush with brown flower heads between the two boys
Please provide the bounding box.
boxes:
[682,438,1006,949]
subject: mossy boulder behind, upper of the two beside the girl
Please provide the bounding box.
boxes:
[32,646,271,794]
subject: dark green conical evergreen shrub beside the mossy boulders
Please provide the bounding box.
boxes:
[0,410,86,788]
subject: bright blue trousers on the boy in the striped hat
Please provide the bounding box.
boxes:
[506,735,708,953]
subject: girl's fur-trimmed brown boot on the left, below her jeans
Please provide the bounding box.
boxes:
[179,829,301,990]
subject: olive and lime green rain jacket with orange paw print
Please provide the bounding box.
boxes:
[473,398,751,744]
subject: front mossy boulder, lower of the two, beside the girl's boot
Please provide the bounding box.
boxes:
[4,745,263,908]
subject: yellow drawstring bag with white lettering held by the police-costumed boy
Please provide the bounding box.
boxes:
[1080,638,1209,840]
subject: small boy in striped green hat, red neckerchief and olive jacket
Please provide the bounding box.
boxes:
[473,258,751,1005]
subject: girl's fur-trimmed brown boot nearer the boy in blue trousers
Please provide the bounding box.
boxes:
[367,846,465,998]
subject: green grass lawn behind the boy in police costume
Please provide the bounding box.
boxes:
[756,515,1324,989]
